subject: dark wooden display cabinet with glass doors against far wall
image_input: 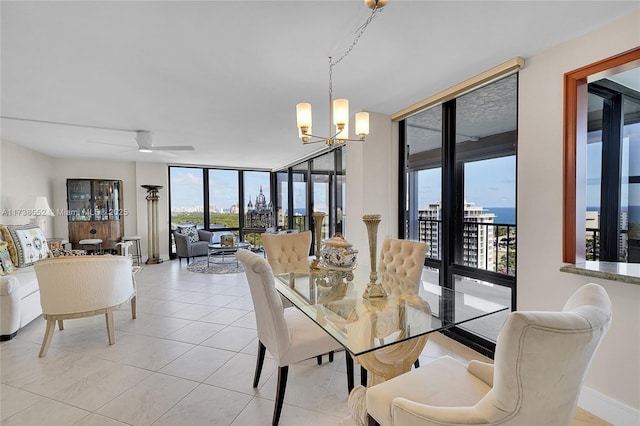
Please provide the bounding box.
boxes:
[67,179,127,250]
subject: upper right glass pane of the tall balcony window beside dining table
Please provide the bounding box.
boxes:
[455,75,517,275]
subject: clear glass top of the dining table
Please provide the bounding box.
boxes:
[274,268,507,356]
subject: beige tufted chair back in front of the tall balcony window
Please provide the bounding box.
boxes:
[378,238,427,290]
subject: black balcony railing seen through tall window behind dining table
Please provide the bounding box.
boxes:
[418,219,517,276]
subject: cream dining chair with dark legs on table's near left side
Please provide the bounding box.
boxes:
[236,249,352,426]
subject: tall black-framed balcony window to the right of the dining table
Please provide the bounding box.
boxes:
[400,74,518,353]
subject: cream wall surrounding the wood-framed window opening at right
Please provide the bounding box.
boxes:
[517,13,640,420]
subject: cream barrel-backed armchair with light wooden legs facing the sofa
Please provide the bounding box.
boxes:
[35,255,136,358]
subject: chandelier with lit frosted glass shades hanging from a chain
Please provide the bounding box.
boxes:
[296,0,388,146]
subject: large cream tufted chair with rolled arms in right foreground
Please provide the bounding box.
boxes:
[357,284,611,426]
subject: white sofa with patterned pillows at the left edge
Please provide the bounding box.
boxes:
[0,225,49,341]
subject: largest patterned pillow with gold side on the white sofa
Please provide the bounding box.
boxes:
[2,225,49,268]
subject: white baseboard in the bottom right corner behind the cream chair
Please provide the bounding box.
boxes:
[578,386,640,426]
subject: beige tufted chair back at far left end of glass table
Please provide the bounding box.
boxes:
[262,231,311,274]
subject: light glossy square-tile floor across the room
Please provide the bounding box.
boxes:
[0,261,486,426]
